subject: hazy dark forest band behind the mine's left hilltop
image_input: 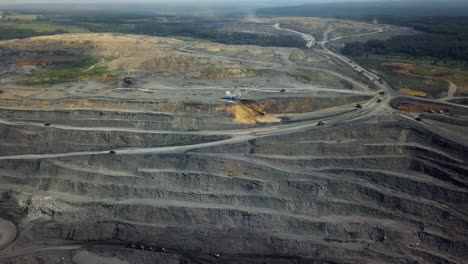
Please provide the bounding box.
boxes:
[0,12,304,48]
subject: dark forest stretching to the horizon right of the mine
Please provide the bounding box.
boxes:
[257,0,468,61]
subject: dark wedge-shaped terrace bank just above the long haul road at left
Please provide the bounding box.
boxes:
[0,127,227,155]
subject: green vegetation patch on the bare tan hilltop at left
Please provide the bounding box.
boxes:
[22,58,115,85]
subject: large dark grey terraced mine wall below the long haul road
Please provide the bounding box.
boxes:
[0,117,468,263]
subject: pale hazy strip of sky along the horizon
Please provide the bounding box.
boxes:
[0,0,468,16]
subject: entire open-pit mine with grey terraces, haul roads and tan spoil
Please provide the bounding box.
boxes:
[0,18,468,264]
